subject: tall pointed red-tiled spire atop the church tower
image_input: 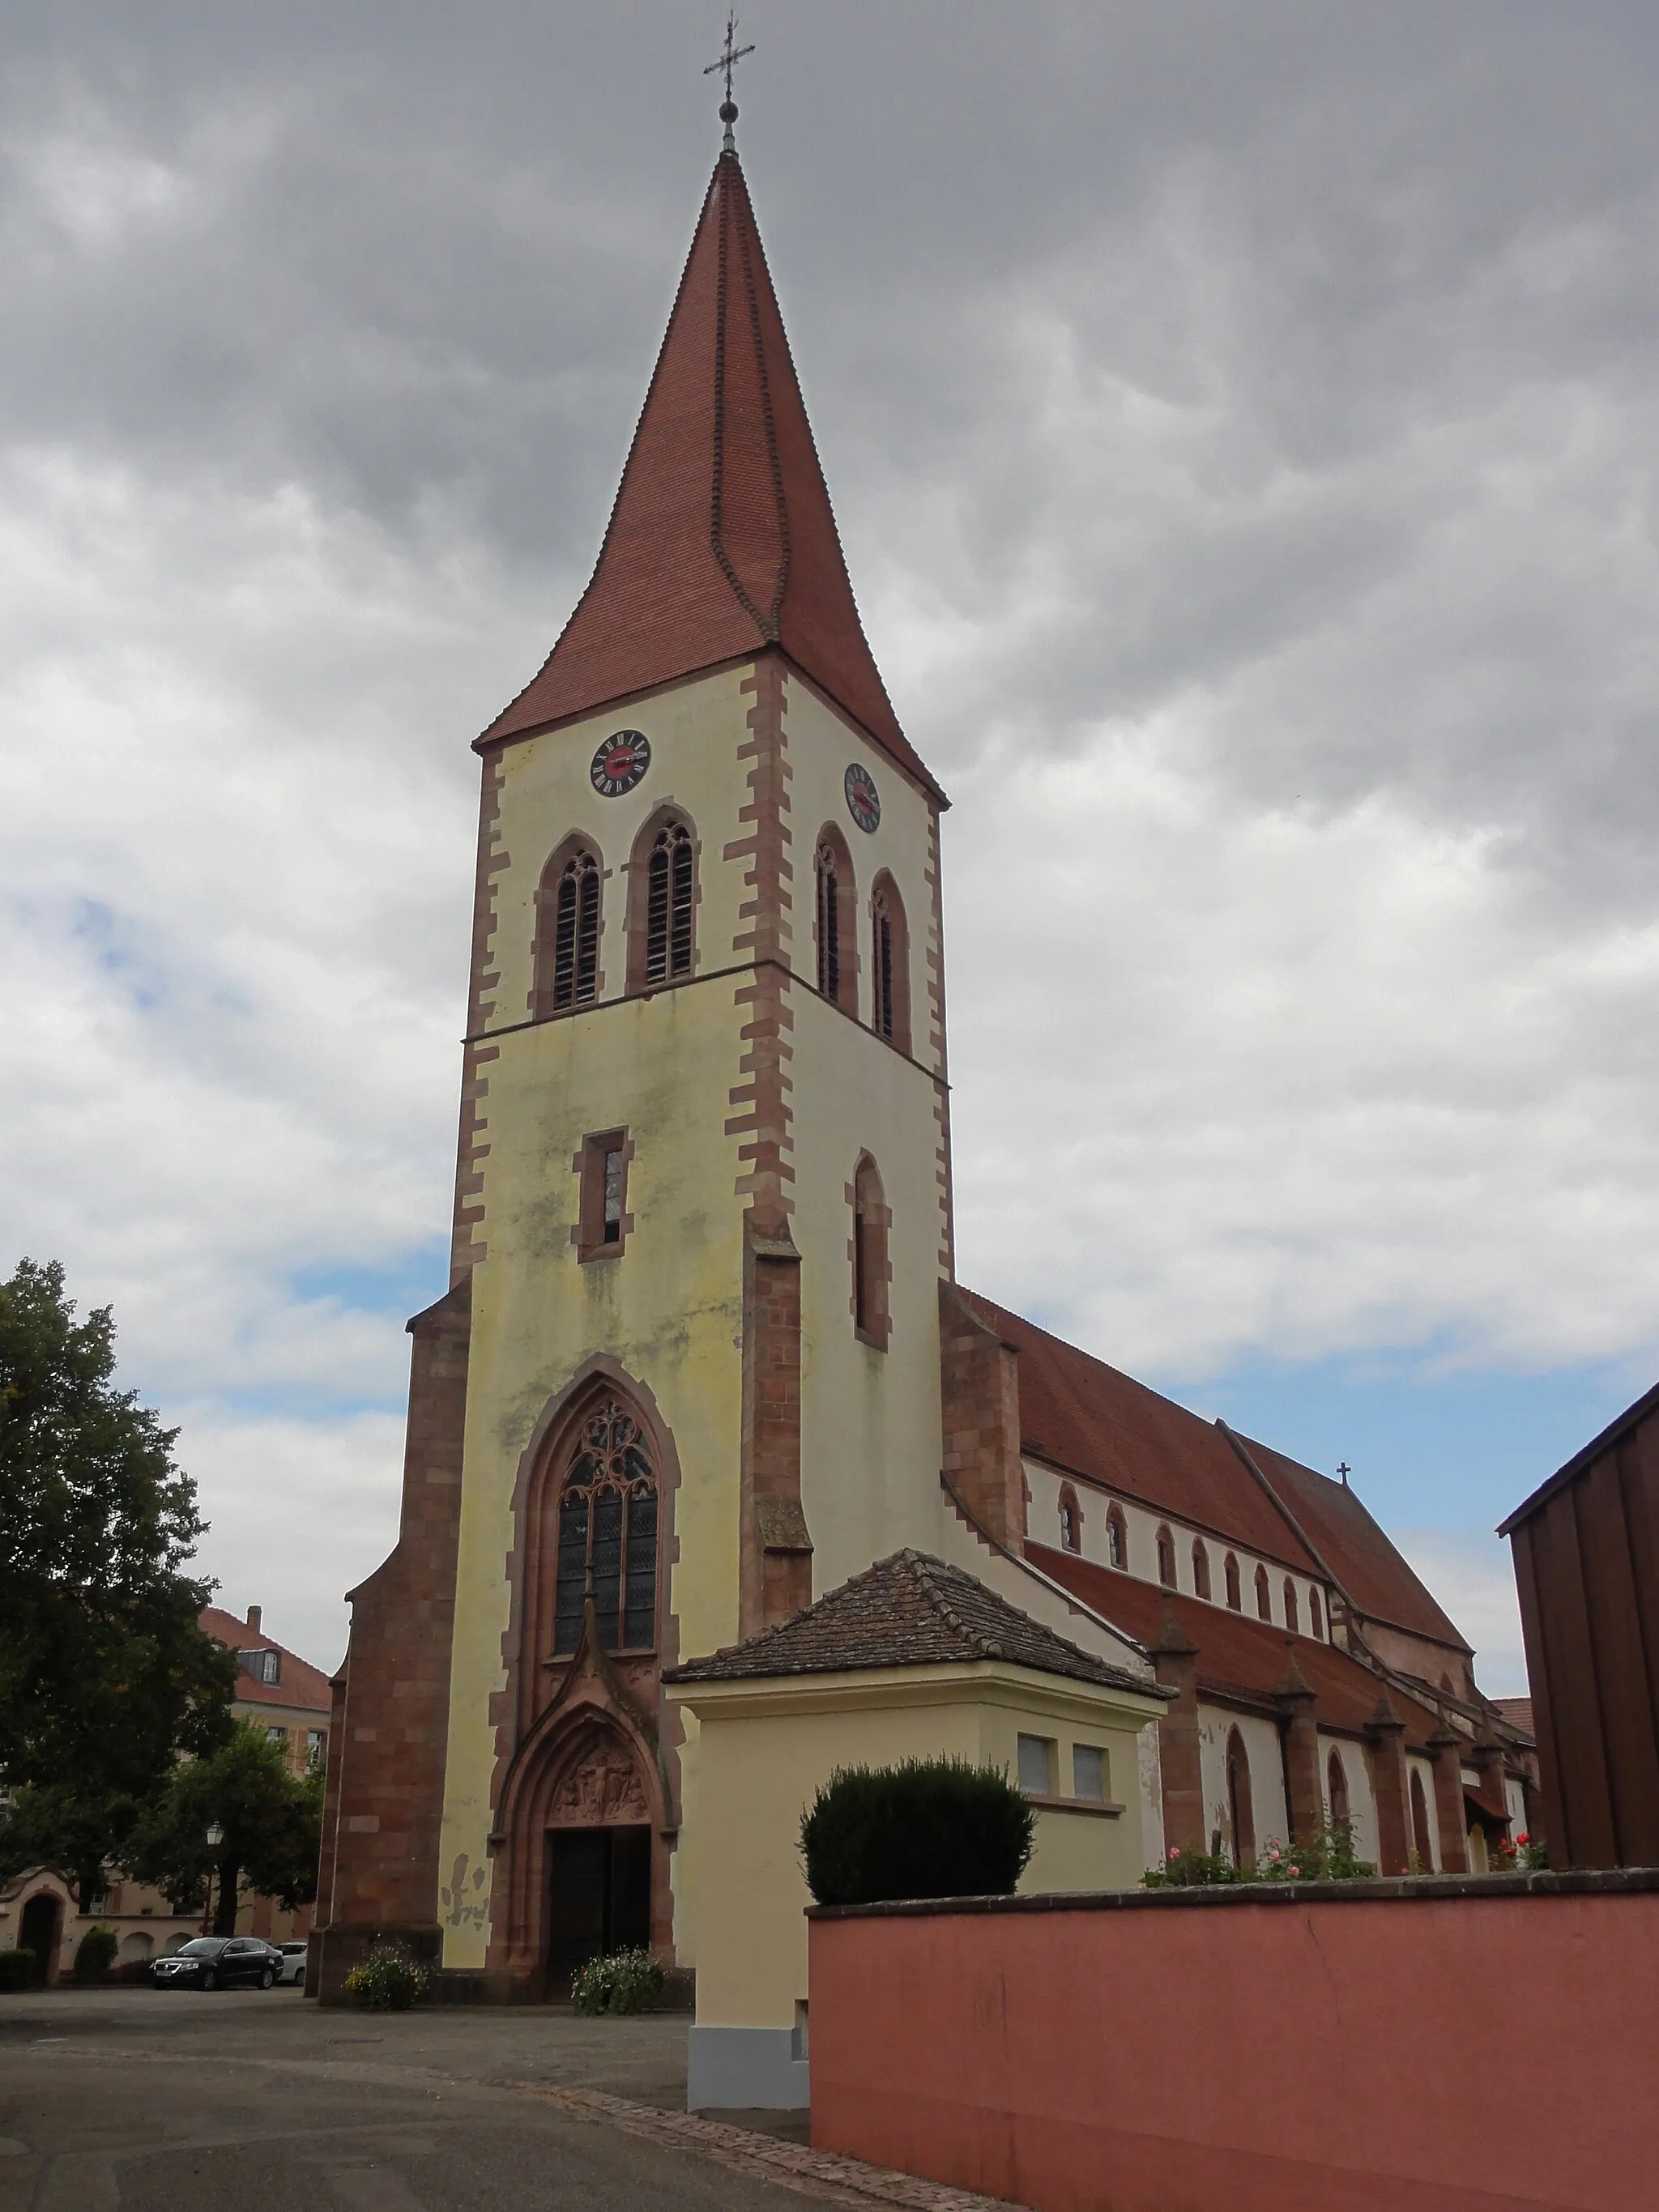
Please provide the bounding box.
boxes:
[480,152,942,796]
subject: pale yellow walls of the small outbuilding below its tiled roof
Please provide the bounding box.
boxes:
[670,1664,1157,2028]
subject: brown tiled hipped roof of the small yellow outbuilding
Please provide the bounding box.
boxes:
[663,1550,1163,1697]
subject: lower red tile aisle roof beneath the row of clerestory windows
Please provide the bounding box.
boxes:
[1026,1544,1438,1750]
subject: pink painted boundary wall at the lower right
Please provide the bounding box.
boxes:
[809,1889,1659,2212]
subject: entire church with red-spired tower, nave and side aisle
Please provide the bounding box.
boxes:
[312,134,1531,2035]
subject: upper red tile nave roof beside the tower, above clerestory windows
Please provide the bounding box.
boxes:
[965,1292,1318,1575]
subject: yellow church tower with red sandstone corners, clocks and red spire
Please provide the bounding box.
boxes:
[318,146,951,1995]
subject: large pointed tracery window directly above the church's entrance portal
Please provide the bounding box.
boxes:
[553,1398,657,1657]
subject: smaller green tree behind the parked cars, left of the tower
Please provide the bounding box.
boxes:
[124,1721,323,1936]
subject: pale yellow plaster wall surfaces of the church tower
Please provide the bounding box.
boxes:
[440,668,960,1967]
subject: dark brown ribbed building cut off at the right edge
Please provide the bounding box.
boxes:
[1498,1387,1659,1867]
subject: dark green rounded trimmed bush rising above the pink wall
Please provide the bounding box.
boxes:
[801,1758,1035,1904]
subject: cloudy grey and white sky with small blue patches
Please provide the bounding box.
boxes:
[0,0,1659,1692]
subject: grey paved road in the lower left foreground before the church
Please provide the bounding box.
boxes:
[0,1988,803,2212]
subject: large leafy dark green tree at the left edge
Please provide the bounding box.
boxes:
[0,1259,237,1840]
